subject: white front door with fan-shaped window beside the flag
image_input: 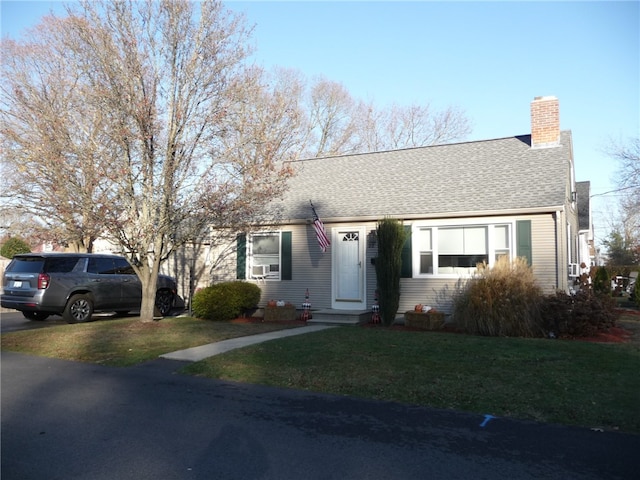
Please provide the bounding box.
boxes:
[331,227,366,310]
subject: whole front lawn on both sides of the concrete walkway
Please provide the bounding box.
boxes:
[1,317,640,433]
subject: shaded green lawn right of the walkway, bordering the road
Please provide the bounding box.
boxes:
[185,328,640,432]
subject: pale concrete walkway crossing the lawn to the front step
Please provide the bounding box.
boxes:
[160,325,335,362]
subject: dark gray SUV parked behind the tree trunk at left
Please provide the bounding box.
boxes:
[0,253,176,323]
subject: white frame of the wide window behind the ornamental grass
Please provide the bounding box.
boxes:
[411,217,516,278]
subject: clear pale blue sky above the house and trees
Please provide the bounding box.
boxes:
[0,0,640,248]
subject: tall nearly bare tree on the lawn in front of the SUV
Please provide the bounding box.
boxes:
[3,0,289,321]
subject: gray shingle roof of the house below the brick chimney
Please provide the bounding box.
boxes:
[272,131,572,220]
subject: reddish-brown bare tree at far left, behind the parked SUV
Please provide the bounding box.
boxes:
[0,26,108,251]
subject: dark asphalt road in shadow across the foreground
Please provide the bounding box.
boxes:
[1,352,640,480]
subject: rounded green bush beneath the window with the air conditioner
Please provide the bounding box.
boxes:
[191,281,261,321]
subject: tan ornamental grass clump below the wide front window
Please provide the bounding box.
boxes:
[453,258,543,337]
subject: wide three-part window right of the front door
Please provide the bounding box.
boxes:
[413,223,513,276]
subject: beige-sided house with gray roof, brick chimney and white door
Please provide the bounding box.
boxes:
[220,97,592,321]
